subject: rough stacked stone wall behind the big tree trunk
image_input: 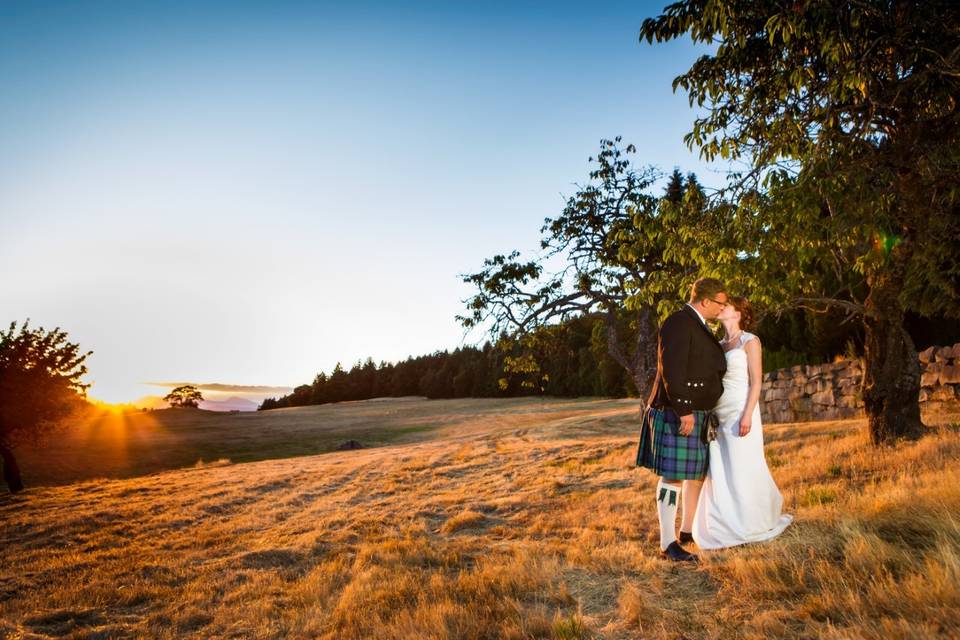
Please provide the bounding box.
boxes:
[760,343,960,422]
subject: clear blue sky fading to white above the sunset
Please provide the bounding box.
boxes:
[0,1,719,402]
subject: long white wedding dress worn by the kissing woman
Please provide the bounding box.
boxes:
[693,332,793,549]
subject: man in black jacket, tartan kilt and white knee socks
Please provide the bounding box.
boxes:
[637,278,727,562]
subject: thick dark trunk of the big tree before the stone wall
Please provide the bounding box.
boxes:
[863,256,924,444]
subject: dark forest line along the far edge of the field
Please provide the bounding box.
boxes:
[258,280,960,411]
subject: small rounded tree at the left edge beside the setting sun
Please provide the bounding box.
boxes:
[0,320,93,493]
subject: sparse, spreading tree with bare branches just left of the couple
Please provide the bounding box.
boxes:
[458,137,697,394]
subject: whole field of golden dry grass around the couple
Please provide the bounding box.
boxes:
[0,400,960,640]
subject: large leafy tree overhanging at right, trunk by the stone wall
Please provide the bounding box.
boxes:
[641,0,960,443]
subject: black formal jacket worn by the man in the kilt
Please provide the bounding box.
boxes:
[649,305,727,416]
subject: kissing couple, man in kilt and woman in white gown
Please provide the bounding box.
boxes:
[636,278,793,562]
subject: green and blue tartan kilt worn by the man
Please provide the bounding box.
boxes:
[637,407,710,480]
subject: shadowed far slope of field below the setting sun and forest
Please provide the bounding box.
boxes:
[17,398,637,486]
